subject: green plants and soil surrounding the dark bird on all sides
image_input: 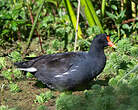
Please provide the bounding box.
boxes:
[0,0,138,110]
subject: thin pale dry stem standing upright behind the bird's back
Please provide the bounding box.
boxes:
[74,0,80,52]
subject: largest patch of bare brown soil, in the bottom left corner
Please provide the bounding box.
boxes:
[0,78,59,110]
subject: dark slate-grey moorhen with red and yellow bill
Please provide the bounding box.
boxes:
[14,34,115,91]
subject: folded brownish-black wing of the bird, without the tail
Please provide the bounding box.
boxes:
[32,52,82,74]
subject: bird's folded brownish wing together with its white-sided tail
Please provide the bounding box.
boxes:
[15,52,83,74]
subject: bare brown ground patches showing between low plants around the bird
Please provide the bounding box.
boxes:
[0,40,108,110]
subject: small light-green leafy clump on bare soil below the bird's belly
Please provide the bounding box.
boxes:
[35,91,54,103]
